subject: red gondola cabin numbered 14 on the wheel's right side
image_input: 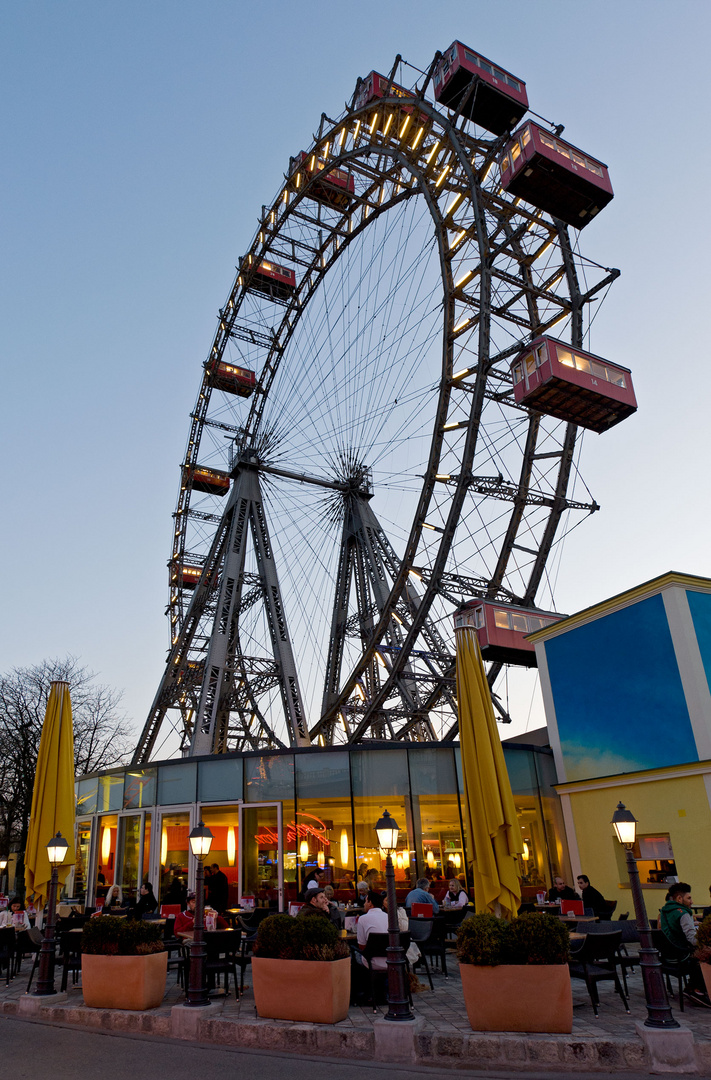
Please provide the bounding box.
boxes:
[511,336,636,433]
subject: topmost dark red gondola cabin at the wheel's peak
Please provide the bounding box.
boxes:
[433,41,528,135]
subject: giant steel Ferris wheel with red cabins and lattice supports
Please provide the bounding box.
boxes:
[134,42,630,764]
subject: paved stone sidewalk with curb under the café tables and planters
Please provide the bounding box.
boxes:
[0,956,711,1077]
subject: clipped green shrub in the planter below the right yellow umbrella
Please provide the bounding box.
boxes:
[457,912,571,967]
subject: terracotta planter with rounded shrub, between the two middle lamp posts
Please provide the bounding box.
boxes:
[252,915,350,1024]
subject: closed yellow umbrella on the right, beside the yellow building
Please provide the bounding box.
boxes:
[455,626,523,919]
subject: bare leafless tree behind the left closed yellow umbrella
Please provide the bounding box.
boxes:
[0,657,133,869]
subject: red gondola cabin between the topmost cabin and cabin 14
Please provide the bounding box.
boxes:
[500,120,614,229]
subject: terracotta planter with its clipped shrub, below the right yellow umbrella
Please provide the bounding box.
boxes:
[457,913,573,1034]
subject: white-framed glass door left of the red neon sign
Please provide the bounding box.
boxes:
[239,802,284,912]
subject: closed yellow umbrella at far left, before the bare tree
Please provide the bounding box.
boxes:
[25,681,75,908]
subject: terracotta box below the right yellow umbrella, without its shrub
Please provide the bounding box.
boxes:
[459,963,573,1035]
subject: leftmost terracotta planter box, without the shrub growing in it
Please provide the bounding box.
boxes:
[81,951,167,1009]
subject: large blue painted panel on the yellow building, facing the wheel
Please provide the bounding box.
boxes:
[546,594,695,780]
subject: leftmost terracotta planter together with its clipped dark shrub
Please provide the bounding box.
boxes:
[81,915,167,1009]
